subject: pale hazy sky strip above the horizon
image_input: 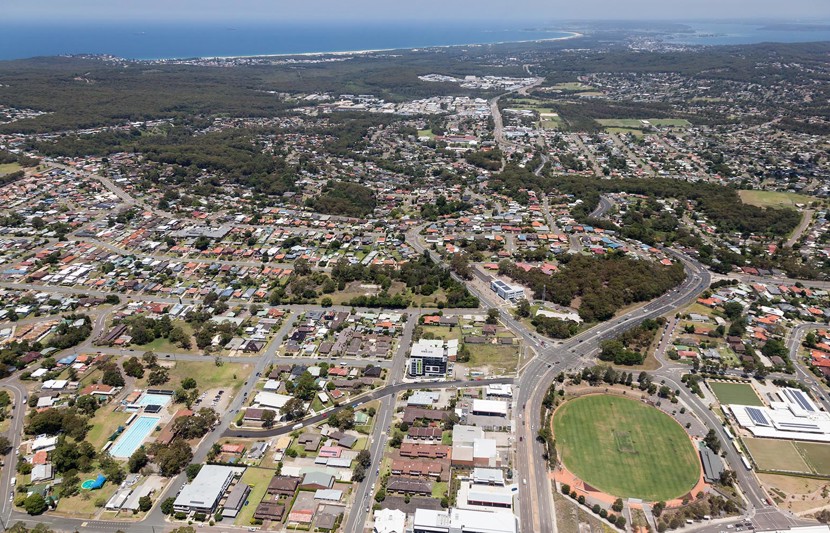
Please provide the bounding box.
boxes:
[6,0,830,23]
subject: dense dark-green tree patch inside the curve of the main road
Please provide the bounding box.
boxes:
[499,254,686,322]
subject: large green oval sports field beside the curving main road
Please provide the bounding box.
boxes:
[553,395,701,501]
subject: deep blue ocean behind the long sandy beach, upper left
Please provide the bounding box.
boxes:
[0,22,571,59]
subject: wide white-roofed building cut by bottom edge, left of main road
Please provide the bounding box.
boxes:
[413,509,518,533]
